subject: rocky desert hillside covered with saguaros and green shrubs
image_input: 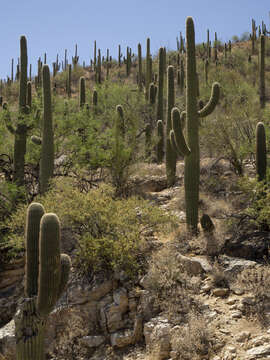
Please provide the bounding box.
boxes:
[0,17,270,360]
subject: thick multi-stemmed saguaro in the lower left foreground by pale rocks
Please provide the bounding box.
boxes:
[14,203,71,360]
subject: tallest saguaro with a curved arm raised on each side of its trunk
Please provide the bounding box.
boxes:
[170,17,220,232]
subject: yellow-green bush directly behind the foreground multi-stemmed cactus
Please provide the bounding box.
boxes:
[1,179,175,274]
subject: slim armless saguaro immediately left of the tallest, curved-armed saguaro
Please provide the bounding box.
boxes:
[166,65,176,186]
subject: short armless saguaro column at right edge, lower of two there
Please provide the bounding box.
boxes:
[256,122,267,181]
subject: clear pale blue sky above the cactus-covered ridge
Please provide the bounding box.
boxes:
[0,0,270,78]
